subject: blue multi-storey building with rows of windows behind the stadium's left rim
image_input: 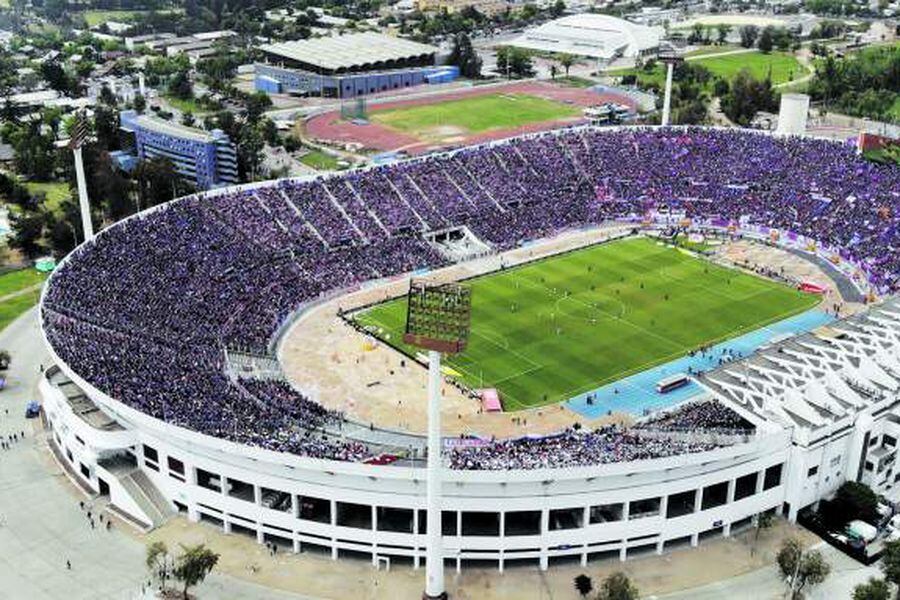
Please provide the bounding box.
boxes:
[119,110,238,190]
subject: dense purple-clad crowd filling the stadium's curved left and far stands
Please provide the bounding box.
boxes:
[43,128,900,468]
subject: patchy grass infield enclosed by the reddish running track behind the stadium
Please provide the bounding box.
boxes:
[369,94,581,135]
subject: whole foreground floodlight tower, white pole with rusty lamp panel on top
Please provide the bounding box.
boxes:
[403,281,472,600]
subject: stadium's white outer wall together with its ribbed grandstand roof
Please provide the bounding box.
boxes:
[40,124,900,571]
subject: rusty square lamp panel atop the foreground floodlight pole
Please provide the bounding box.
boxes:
[403,280,472,354]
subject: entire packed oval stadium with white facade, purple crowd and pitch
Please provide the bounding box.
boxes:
[41,127,900,571]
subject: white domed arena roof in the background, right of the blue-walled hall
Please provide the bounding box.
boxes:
[511,13,663,60]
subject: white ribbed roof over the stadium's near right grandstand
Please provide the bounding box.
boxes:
[700,298,900,437]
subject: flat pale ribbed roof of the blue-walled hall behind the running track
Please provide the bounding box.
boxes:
[260,32,437,71]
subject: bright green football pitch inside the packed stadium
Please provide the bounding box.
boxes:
[354,238,818,411]
